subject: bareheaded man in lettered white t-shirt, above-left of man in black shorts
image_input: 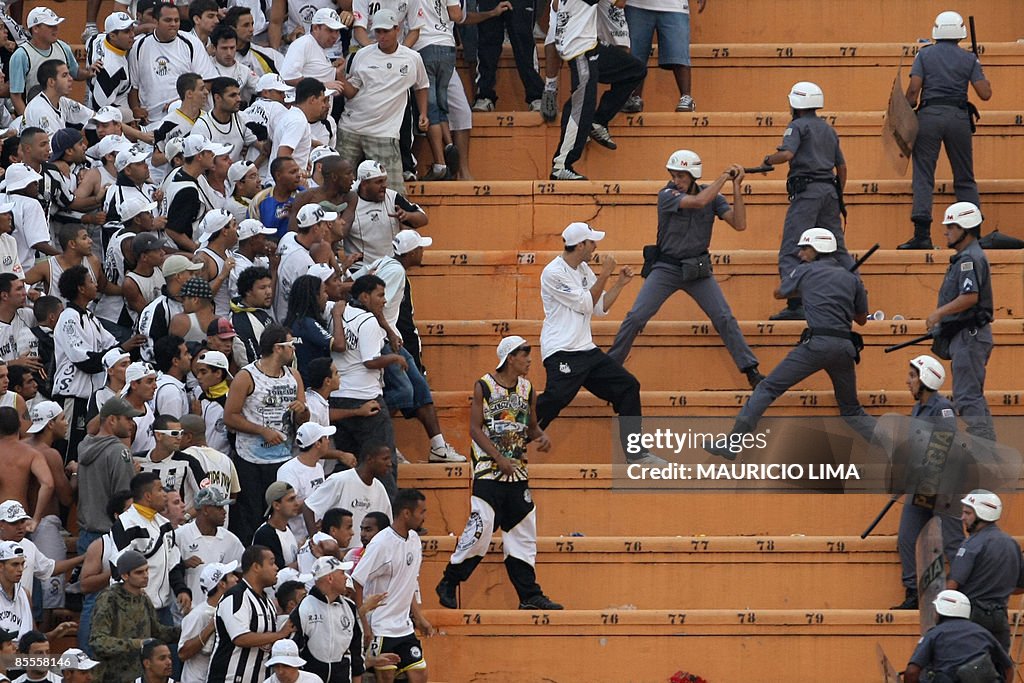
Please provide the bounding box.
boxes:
[302,441,391,545]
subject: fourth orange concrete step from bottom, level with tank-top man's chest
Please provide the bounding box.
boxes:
[394,389,1024,464]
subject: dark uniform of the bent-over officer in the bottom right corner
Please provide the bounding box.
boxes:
[909,618,1013,683]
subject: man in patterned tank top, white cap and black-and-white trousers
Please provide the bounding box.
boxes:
[436,336,562,609]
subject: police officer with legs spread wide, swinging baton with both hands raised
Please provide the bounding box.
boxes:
[608,150,764,389]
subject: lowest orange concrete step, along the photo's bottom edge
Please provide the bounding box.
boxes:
[424,610,920,683]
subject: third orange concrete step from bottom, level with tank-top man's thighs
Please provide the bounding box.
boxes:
[398,464,1024,540]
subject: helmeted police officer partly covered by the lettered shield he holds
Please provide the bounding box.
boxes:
[892,355,964,609]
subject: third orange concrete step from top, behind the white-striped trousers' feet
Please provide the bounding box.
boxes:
[460,109,1024,180]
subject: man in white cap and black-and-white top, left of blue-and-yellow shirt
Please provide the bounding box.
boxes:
[162,133,230,253]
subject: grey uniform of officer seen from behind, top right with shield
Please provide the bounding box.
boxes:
[910,40,985,236]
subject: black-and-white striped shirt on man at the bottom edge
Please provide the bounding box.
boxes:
[207,580,278,683]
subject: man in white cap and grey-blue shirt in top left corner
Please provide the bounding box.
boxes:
[7,7,86,115]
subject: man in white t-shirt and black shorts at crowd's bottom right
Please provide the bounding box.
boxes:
[352,488,434,683]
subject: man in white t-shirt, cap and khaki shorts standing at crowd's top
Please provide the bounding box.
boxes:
[338,9,430,193]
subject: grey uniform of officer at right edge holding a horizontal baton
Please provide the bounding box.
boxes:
[939,240,995,441]
